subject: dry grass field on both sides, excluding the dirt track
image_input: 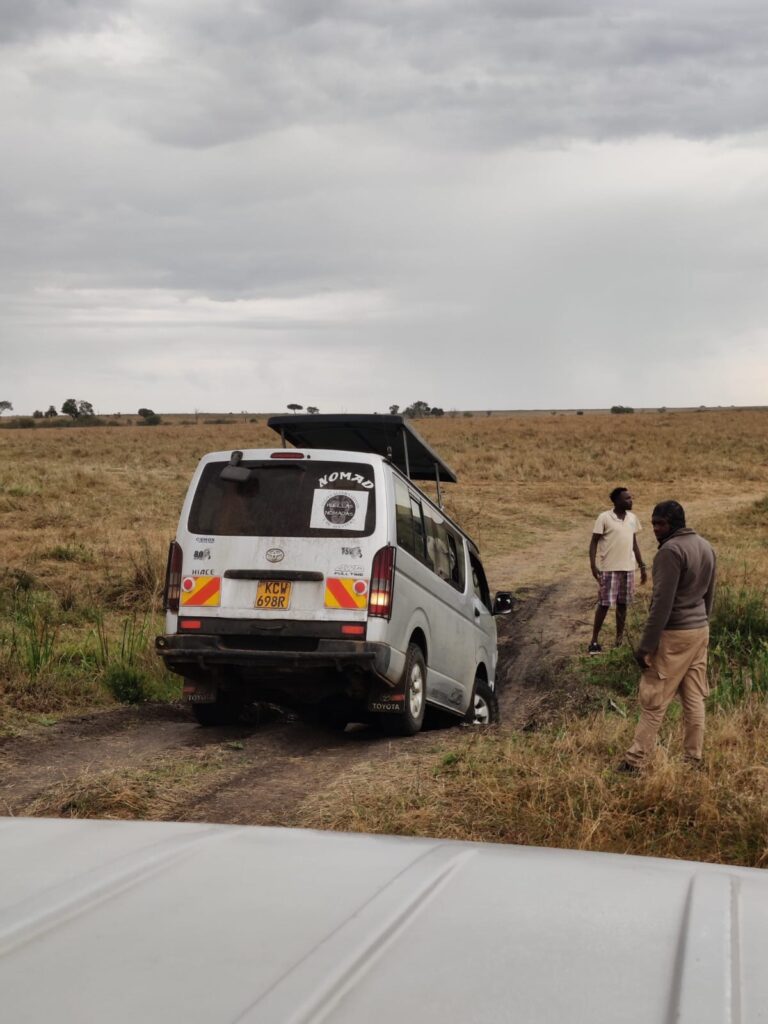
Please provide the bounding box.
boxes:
[0,410,768,865]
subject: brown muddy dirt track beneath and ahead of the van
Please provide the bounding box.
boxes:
[0,581,591,824]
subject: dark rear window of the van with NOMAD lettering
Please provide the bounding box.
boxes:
[187,460,376,537]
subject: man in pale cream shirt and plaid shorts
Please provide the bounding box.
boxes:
[587,487,648,654]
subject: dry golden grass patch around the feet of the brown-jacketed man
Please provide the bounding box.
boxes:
[293,701,768,867]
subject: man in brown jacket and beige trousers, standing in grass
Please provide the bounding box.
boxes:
[618,501,716,771]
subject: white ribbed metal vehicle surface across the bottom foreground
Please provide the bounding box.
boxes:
[0,818,768,1024]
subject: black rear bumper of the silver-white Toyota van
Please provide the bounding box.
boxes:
[155,634,390,678]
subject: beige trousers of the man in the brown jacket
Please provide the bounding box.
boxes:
[626,626,710,767]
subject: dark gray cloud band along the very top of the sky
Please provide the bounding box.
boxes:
[13,0,768,148]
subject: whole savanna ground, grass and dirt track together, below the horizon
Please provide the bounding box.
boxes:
[0,410,768,866]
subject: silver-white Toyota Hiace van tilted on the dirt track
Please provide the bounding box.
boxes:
[156,415,512,734]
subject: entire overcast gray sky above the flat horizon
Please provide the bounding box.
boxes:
[0,0,768,414]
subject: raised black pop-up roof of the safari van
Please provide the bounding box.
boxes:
[266,413,456,483]
